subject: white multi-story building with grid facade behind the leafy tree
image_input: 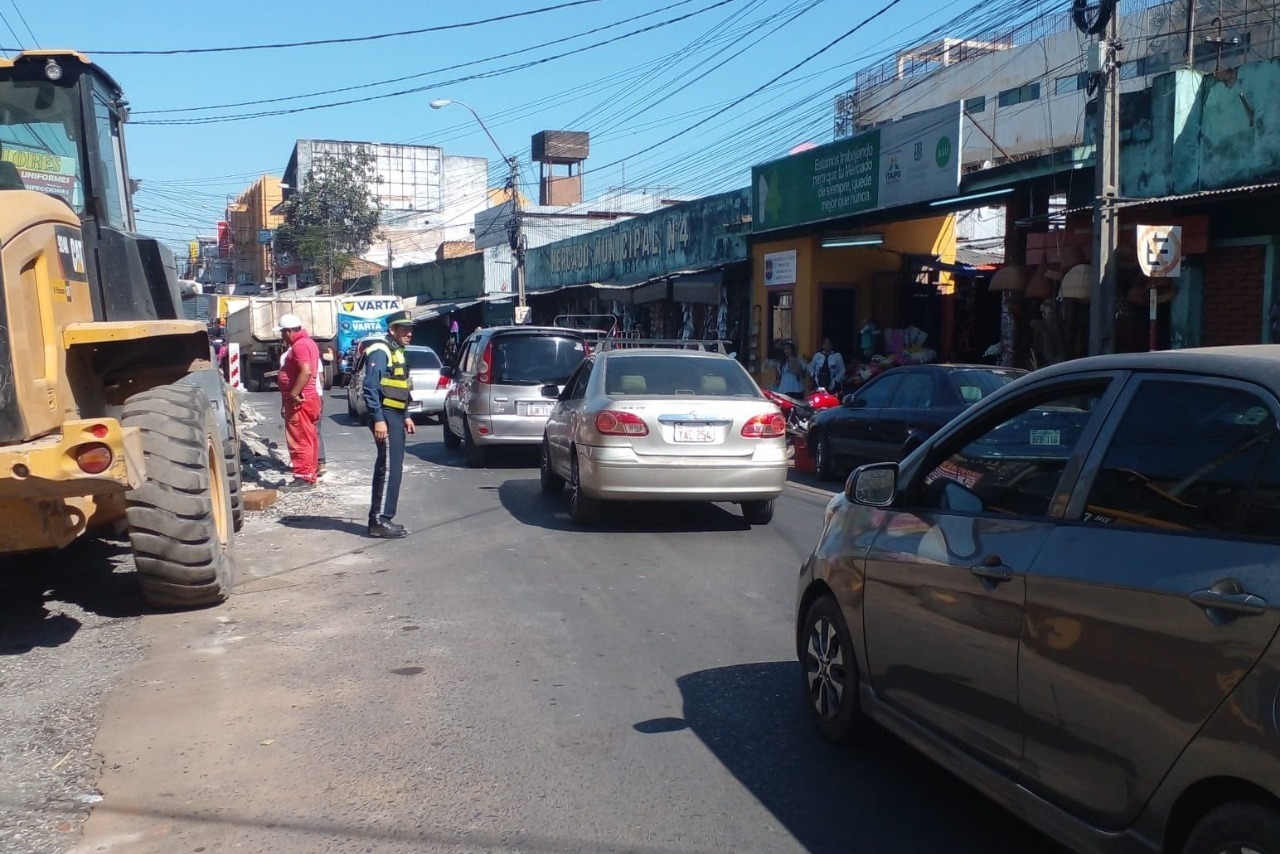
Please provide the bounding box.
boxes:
[284,140,489,266]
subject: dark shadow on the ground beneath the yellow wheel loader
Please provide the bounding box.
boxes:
[0,539,152,656]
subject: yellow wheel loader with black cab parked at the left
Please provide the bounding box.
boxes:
[0,50,243,607]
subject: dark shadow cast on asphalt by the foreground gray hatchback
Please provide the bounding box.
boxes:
[645,662,1065,854]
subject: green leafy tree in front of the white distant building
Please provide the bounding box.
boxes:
[278,149,381,293]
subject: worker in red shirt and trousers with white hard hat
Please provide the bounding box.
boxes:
[276,314,323,492]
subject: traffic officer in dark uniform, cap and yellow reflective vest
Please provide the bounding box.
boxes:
[361,311,413,539]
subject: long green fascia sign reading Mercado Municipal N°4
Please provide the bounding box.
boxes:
[525,188,751,291]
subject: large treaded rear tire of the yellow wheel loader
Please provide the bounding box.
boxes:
[122,385,234,608]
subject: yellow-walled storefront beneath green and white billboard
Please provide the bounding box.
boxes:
[750,104,960,384]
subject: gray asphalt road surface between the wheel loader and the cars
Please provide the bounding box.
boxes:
[12,394,1056,854]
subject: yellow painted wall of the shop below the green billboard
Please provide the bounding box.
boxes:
[751,214,956,383]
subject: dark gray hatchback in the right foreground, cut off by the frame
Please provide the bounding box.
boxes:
[796,346,1280,854]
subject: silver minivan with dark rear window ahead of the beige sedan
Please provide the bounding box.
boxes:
[443,326,589,467]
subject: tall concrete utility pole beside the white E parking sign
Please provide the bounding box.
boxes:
[1089,0,1120,356]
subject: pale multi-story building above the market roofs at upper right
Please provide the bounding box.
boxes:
[836,0,1280,170]
